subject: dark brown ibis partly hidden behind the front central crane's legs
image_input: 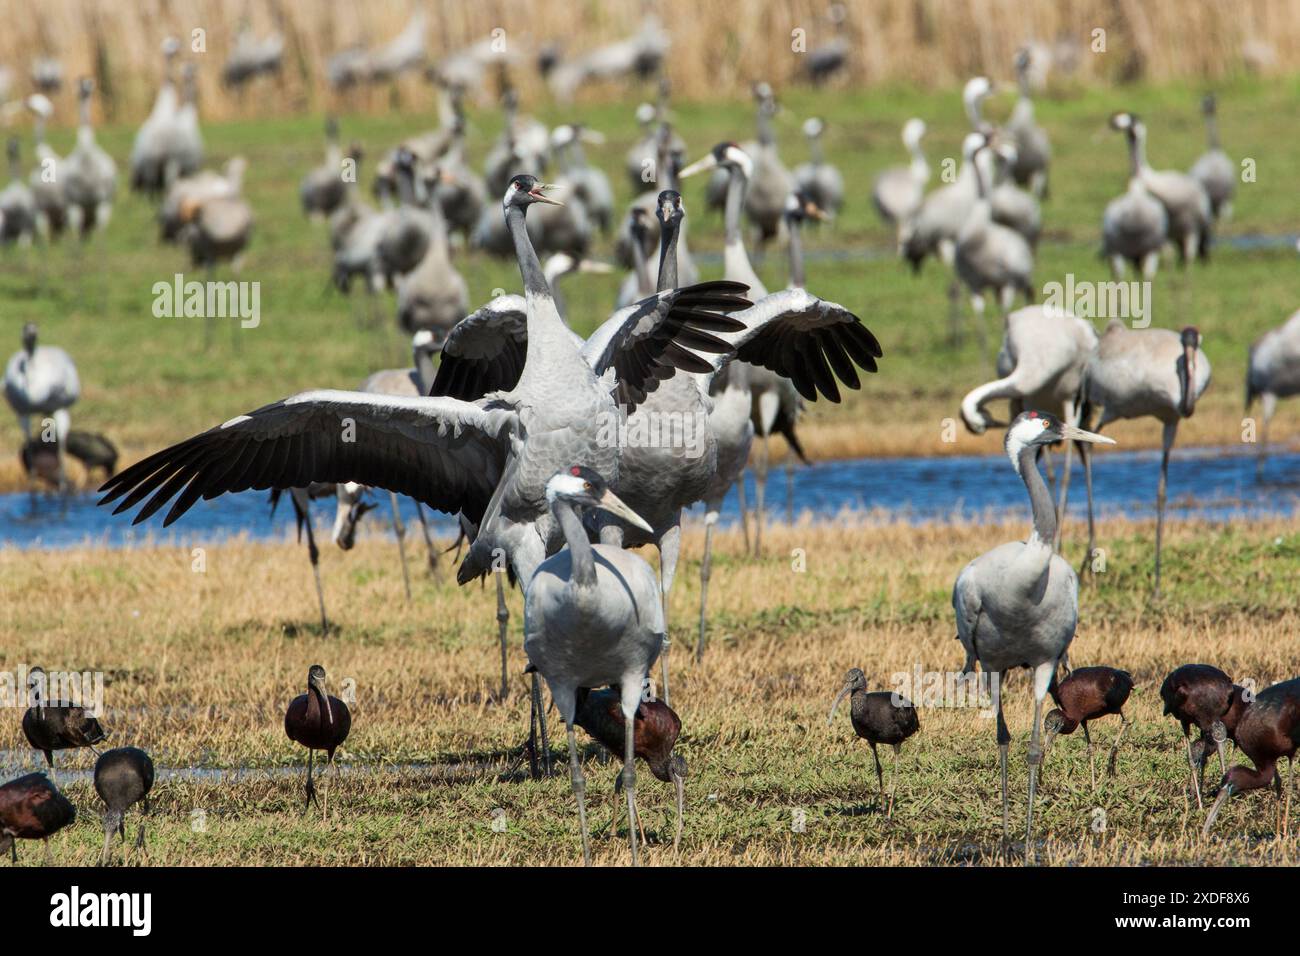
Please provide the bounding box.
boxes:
[573,687,686,849]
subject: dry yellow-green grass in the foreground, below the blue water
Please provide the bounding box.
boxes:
[0,520,1300,865]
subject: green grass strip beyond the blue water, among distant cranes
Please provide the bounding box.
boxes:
[0,81,1300,489]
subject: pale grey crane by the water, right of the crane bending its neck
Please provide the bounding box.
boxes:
[1080,325,1210,597]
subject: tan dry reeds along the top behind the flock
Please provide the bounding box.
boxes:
[0,0,1300,122]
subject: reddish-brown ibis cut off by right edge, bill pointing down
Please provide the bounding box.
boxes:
[1201,678,1300,839]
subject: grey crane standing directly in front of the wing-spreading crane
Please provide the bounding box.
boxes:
[524,466,664,866]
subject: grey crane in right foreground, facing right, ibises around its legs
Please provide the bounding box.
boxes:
[953,411,1114,860]
